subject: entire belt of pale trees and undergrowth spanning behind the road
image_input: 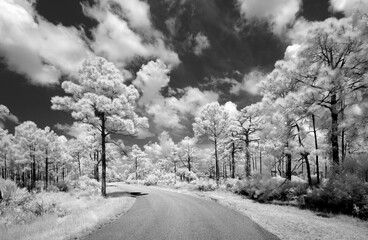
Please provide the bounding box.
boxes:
[0,9,368,225]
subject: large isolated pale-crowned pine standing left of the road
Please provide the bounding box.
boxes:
[51,57,148,196]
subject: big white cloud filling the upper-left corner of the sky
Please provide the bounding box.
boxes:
[0,0,90,85]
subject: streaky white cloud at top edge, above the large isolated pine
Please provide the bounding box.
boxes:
[84,0,180,67]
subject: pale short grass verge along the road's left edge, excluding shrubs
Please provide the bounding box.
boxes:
[0,187,135,240]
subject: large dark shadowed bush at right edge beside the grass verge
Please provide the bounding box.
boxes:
[304,174,368,219]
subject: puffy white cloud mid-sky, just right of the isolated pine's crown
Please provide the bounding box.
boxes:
[133,60,219,129]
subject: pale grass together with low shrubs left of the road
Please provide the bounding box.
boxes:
[0,176,134,240]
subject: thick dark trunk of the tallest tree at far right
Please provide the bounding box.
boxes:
[331,94,340,173]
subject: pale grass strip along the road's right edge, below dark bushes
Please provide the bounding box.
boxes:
[160,183,368,240]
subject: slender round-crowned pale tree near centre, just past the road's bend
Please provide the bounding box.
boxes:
[193,102,229,185]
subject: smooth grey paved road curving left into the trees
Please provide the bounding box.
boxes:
[85,183,278,240]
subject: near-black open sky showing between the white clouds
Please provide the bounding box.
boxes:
[0,0,331,144]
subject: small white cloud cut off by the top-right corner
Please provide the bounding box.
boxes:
[330,0,368,16]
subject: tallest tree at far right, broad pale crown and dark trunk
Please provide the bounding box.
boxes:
[296,18,368,173]
